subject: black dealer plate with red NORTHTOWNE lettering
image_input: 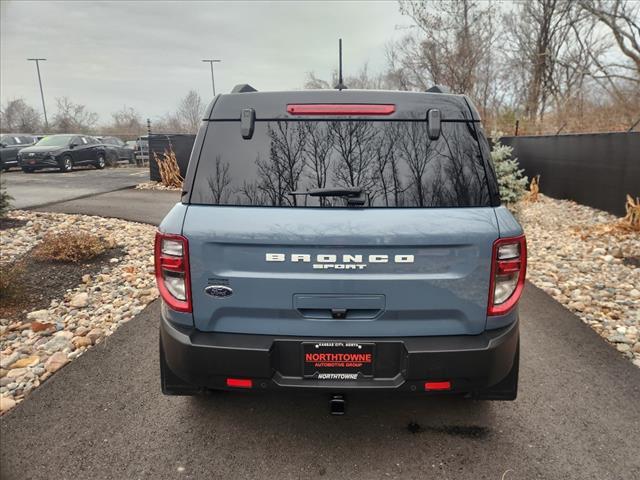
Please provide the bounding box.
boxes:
[302,342,375,380]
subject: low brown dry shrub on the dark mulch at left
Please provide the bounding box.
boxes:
[31,231,113,263]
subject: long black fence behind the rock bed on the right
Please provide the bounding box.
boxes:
[501,132,640,215]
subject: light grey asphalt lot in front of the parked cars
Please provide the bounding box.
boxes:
[2,167,149,209]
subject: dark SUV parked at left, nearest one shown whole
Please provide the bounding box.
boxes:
[18,134,106,173]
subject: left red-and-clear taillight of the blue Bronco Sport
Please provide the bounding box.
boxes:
[155,232,192,312]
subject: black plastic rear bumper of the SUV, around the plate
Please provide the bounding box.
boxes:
[160,318,519,393]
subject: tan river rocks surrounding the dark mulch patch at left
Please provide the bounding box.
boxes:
[0,210,158,414]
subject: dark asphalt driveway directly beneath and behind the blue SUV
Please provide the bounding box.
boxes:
[0,285,640,480]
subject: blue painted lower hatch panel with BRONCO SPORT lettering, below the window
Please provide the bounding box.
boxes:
[184,206,498,337]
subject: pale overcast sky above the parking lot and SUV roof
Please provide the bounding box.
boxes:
[0,0,410,122]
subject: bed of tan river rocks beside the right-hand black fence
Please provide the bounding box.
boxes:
[516,195,640,367]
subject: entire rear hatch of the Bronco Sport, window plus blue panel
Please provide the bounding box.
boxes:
[183,95,499,337]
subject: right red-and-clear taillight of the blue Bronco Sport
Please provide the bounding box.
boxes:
[487,235,527,315]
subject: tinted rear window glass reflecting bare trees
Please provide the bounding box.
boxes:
[191,120,490,207]
